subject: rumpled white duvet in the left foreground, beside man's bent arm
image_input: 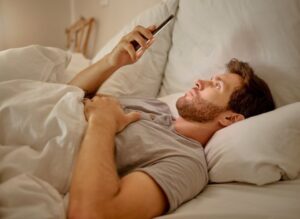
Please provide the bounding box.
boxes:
[0,80,86,219]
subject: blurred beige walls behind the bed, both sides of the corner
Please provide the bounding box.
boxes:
[0,0,160,57]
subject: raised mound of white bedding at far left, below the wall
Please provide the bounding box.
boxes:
[0,45,71,82]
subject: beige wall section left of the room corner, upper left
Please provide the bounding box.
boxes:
[0,0,70,50]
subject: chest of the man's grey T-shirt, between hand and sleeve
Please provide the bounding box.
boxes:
[115,114,201,175]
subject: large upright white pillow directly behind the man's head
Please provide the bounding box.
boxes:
[160,0,300,106]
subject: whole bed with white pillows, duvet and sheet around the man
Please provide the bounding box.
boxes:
[0,0,300,219]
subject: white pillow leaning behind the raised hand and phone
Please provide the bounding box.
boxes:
[92,0,178,97]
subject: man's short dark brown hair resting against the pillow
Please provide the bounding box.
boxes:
[226,59,275,118]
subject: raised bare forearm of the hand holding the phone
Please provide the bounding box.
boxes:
[69,54,119,94]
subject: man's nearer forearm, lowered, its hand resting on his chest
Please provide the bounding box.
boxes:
[69,122,120,218]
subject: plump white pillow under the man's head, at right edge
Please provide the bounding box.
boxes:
[205,102,300,185]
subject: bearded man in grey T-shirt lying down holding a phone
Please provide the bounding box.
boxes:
[68,26,274,219]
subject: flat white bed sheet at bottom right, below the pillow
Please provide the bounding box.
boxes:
[157,177,300,219]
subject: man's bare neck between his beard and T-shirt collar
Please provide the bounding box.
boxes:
[174,117,221,146]
